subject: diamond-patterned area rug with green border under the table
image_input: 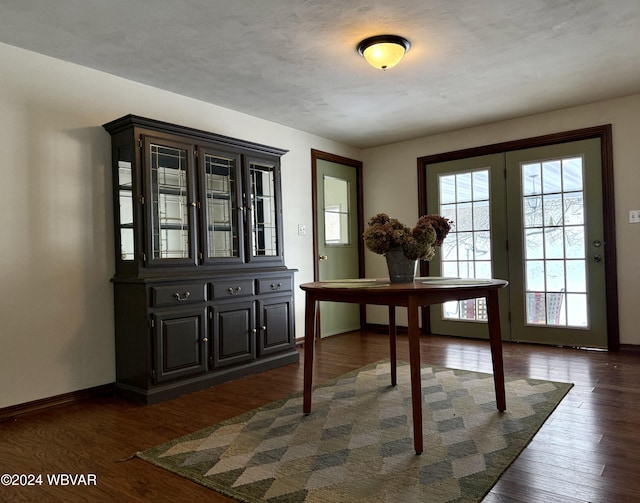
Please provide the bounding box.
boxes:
[137,361,572,503]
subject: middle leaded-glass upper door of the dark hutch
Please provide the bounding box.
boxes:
[199,149,244,263]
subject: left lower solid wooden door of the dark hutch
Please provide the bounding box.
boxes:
[153,307,207,383]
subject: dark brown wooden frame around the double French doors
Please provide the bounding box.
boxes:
[417,124,620,351]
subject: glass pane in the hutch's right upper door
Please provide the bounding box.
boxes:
[249,163,278,257]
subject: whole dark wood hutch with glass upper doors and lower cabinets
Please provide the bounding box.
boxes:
[104,115,298,403]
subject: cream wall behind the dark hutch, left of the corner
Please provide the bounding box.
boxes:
[0,44,360,408]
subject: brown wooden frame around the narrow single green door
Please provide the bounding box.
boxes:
[311,149,366,328]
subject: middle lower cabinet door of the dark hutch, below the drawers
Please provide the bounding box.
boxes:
[213,301,256,367]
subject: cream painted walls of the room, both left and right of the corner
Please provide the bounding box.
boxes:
[0,39,640,408]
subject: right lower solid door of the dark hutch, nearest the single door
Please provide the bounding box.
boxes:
[259,297,294,355]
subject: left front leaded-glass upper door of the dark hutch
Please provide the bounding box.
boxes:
[145,138,197,264]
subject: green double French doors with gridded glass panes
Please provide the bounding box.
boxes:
[425,138,608,348]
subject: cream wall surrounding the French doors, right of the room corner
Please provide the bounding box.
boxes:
[363,95,640,344]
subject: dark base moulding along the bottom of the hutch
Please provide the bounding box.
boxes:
[115,351,300,405]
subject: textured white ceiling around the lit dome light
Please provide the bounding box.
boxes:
[0,0,640,147]
